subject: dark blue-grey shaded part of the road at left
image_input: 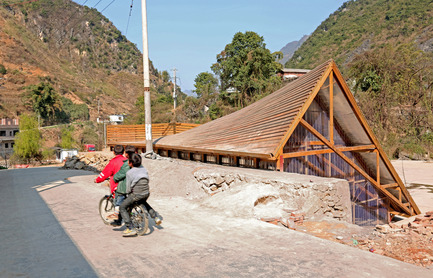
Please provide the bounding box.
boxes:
[0,168,97,277]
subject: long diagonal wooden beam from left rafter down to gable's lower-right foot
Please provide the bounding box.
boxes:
[300,119,411,214]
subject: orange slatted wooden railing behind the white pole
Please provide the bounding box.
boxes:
[107,123,199,145]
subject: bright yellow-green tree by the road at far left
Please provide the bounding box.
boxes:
[14,115,42,162]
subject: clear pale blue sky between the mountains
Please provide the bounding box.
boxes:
[74,0,347,92]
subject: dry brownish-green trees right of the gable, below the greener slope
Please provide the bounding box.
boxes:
[349,44,433,156]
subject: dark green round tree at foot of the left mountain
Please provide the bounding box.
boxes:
[24,82,62,121]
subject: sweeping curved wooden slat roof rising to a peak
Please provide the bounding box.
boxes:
[155,60,333,159]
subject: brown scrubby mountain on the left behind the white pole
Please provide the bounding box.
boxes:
[0,0,179,122]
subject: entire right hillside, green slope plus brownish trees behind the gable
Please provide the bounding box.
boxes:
[285,0,433,158]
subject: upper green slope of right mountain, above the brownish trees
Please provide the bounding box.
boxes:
[285,0,433,68]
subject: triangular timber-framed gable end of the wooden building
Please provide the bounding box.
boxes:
[274,60,420,219]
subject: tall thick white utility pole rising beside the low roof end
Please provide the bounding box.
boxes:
[141,0,153,153]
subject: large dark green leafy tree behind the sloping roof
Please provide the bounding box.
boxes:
[211,31,282,106]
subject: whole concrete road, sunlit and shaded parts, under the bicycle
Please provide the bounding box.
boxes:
[0,167,433,277]
